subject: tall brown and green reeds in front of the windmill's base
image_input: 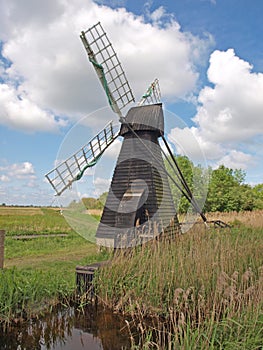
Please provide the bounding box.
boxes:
[96,225,263,349]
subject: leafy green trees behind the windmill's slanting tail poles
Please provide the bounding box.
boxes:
[165,156,263,213]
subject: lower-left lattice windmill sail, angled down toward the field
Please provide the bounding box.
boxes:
[45,121,119,196]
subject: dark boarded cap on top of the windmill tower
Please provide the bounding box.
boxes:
[120,103,164,136]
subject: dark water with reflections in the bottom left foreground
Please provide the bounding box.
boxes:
[0,306,130,350]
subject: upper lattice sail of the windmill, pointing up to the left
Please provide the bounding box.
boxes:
[80,22,135,117]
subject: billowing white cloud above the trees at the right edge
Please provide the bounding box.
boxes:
[170,49,263,169]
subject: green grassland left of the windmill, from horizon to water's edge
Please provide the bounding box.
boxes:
[0,208,107,322]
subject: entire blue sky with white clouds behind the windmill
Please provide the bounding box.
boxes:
[0,0,263,205]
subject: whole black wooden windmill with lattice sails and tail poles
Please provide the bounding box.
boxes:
[46,22,210,248]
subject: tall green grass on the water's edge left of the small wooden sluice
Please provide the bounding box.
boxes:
[0,267,74,323]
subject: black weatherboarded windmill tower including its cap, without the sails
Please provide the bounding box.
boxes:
[96,103,182,248]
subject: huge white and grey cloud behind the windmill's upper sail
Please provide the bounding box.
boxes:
[0,0,211,131]
